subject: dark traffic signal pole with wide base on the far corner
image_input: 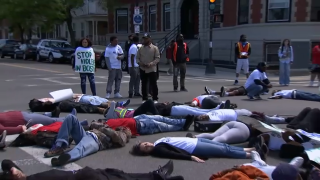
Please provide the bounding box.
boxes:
[205,0,216,75]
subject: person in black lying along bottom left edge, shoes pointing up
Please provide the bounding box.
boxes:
[0,159,184,180]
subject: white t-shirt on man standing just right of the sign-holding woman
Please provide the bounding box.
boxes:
[104,45,123,69]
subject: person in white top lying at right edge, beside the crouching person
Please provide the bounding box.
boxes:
[269,89,320,102]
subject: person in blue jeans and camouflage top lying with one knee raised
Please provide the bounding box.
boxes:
[44,114,131,166]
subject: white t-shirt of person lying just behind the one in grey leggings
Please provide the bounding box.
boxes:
[206,109,238,121]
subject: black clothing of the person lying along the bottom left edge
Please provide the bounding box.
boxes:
[27,167,183,180]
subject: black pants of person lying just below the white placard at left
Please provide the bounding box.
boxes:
[59,100,99,114]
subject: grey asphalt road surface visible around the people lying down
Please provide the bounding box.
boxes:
[0,59,319,180]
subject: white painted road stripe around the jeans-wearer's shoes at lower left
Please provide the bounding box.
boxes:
[20,146,82,171]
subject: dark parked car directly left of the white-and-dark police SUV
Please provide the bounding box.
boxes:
[14,44,37,60]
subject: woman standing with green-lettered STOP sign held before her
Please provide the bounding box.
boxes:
[73,38,97,96]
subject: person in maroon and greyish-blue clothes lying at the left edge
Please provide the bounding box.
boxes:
[0,111,65,135]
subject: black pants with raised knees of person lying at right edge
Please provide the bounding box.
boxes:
[286,107,320,133]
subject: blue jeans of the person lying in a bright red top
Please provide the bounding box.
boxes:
[134,114,186,135]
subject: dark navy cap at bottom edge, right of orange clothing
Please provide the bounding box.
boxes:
[271,163,299,180]
